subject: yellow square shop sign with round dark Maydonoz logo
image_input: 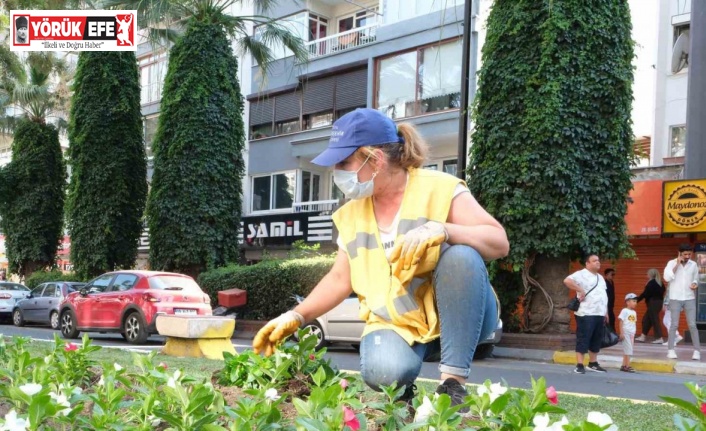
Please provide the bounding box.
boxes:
[662,179,706,233]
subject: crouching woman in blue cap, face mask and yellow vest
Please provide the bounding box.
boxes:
[253,109,509,412]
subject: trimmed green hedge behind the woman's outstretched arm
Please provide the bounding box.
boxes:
[198,256,334,320]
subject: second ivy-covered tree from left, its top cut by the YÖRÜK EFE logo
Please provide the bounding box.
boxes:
[67,51,147,278]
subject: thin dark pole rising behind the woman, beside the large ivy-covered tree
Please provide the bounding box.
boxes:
[456,0,480,180]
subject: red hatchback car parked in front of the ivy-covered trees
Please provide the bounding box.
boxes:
[59,271,212,344]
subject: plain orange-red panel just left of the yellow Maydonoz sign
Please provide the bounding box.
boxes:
[625,180,663,236]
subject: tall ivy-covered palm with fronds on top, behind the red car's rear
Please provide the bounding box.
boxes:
[106,0,306,276]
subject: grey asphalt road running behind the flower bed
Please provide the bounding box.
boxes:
[0,324,706,401]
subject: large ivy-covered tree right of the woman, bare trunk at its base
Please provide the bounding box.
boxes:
[468,0,633,332]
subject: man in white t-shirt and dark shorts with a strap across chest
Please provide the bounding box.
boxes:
[564,254,608,374]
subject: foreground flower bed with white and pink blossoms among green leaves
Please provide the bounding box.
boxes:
[0,333,706,431]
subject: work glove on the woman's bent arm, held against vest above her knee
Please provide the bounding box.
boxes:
[390,221,449,270]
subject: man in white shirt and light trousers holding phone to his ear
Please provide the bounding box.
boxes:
[664,244,701,361]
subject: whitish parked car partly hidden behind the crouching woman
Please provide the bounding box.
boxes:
[294,293,503,359]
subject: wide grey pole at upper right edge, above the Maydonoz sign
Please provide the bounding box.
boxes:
[684,0,706,179]
